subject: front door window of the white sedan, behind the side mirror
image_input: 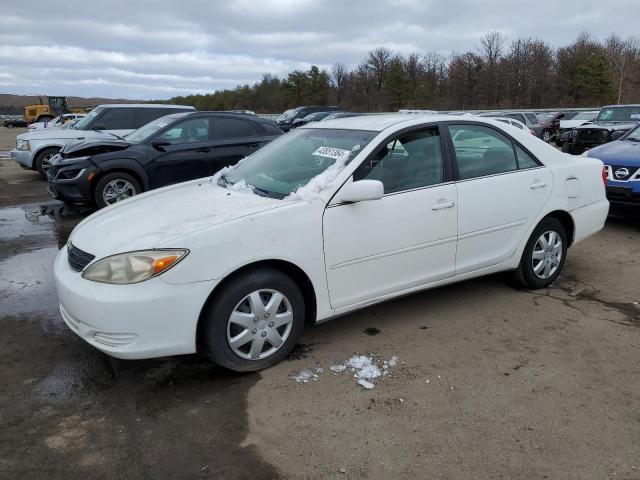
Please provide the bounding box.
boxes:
[353,129,444,193]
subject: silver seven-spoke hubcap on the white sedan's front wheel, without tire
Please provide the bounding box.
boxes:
[227,289,293,360]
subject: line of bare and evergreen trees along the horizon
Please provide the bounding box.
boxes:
[169,32,640,113]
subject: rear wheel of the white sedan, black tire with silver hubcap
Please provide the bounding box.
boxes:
[515,217,568,290]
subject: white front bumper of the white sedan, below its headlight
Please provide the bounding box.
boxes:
[54,246,217,359]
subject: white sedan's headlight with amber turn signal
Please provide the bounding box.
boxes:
[82,249,189,285]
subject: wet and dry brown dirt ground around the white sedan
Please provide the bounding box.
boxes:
[0,128,640,480]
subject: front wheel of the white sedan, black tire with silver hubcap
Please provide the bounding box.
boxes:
[198,268,305,372]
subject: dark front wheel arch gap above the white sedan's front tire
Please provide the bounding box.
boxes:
[196,259,317,351]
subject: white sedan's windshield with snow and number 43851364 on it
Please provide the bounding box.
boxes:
[218,128,377,199]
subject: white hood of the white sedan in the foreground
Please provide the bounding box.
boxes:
[70,178,292,258]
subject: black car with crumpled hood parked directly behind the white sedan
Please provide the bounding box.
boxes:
[47,112,282,208]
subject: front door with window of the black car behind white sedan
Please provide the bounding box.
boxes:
[147,117,213,188]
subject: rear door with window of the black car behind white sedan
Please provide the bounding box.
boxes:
[209,117,266,174]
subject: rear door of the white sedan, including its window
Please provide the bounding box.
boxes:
[449,122,552,275]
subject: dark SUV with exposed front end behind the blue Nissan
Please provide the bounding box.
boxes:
[562,105,640,155]
